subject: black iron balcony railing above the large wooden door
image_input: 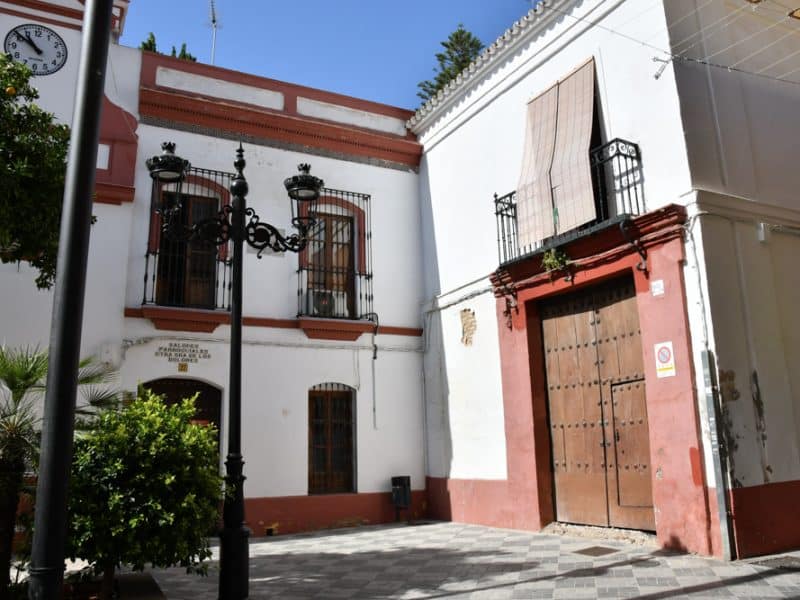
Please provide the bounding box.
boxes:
[494,138,646,265]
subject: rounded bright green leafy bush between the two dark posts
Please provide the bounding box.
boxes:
[68,389,222,597]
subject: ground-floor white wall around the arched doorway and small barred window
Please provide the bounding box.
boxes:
[121,319,425,497]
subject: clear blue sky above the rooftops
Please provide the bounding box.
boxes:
[121,0,530,109]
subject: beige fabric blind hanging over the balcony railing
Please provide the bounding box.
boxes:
[517,59,597,247]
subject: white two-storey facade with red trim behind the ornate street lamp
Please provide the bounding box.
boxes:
[0,0,425,535]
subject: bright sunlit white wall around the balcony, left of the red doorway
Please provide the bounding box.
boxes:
[416,1,691,479]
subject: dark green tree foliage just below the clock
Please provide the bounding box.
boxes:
[0,54,69,288]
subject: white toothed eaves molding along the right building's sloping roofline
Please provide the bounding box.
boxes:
[406,0,582,134]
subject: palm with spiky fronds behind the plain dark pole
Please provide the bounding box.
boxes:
[0,346,117,598]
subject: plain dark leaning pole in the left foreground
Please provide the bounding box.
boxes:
[28,0,112,600]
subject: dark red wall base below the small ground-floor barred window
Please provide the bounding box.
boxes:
[244,490,427,537]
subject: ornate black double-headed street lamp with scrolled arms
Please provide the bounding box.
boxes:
[147,142,323,600]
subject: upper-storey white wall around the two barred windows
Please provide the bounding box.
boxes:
[126,124,422,327]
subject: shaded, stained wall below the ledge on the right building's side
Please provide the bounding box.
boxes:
[698,194,800,486]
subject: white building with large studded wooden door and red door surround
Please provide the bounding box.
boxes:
[409,0,800,557]
